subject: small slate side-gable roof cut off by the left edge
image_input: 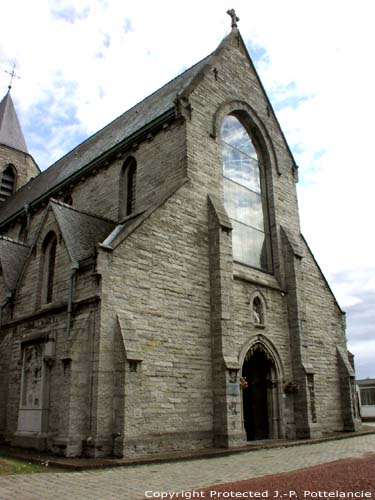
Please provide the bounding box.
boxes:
[0,236,30,291]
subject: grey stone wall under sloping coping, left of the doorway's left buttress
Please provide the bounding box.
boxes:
[98,181,212,455]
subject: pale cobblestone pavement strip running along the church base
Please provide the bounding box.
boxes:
[0,434,375,500]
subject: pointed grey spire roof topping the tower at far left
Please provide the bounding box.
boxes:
[0,91,28,153]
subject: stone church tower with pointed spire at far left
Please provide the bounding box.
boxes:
[0,89,40,203]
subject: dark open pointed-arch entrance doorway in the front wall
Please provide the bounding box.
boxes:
[242,342,281,441]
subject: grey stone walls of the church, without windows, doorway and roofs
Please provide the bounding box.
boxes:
[0,27,358,456]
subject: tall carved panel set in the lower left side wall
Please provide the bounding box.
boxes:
[22,344,43,408]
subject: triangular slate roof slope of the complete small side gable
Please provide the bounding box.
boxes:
[50,200,116,262]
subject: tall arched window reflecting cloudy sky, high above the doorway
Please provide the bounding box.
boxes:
[221,115,272,272]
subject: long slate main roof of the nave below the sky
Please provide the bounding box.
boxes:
[0,54,212,224]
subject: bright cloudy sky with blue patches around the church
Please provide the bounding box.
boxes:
[0,0,375,378]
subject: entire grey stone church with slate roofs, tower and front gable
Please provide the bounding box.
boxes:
[0,26,358,457]
